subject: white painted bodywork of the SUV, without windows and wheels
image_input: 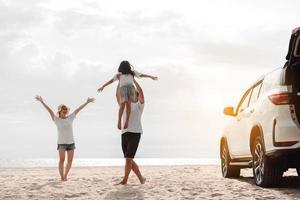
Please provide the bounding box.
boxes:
[222,68,300,159]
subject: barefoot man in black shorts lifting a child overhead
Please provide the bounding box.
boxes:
[116,80,146,185]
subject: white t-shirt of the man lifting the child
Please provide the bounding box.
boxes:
[122,101,144,134]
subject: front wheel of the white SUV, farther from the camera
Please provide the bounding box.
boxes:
[220,143,241,178]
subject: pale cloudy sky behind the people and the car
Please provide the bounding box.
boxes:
[0,0,300,159]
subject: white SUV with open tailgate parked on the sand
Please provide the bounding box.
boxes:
[220,28,300,187]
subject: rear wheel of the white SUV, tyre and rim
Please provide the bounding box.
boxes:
[252,136,283,187]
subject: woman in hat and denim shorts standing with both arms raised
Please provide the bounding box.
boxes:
[35,96,95,181]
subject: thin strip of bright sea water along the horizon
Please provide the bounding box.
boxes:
[0,158,220,168]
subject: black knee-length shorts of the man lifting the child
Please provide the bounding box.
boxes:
[122,132,141,158]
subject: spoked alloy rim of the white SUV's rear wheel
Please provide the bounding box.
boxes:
[253,142,265,185]
